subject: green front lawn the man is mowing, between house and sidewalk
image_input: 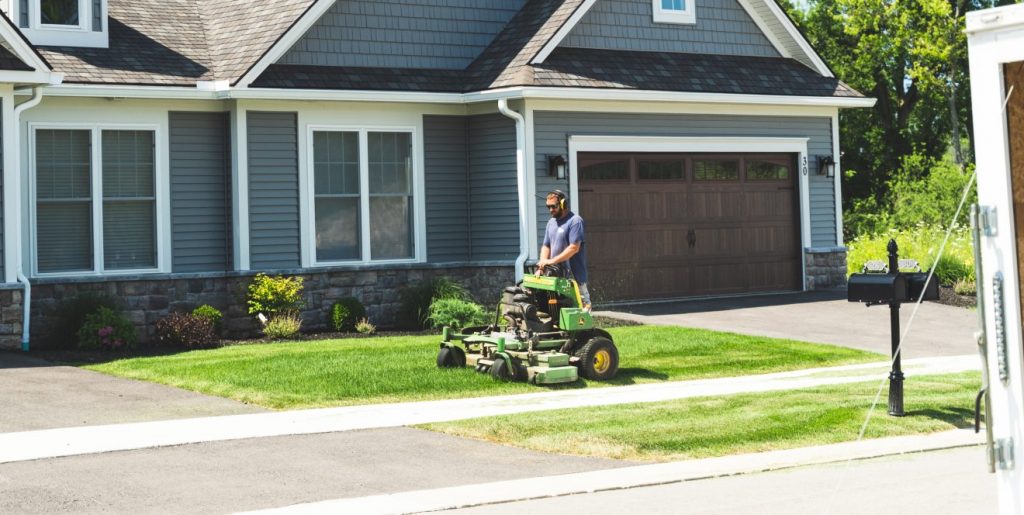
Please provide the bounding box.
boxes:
[86,326,885,410]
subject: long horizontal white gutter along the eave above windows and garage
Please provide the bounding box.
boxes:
[36,83,876,109]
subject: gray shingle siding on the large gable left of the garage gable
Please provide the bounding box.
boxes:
[279,0,525,70]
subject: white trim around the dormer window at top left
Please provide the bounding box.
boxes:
[17,0,109,48]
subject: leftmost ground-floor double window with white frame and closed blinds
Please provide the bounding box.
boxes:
[30,125,162,276]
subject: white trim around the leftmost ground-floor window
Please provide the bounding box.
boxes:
[28,123,171,277]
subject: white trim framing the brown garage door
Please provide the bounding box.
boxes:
[569,136,811,290]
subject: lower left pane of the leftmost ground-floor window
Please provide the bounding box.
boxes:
[36,202,93,272]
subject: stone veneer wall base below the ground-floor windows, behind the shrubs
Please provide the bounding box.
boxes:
[0,265,514,349]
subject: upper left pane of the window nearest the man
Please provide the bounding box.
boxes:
[313,132,359,195]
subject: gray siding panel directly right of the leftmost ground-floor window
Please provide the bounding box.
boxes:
[170,113,233,272]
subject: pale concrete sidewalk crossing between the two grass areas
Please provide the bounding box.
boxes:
[0,355,980,463]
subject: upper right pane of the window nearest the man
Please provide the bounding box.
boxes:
[368,132,413,194]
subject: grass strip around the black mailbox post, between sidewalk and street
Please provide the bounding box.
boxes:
[421,373,981,461]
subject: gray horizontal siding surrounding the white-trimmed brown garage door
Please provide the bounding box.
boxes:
[534,112,836,247]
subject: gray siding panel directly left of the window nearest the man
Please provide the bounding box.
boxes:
[247,112,301,270]
